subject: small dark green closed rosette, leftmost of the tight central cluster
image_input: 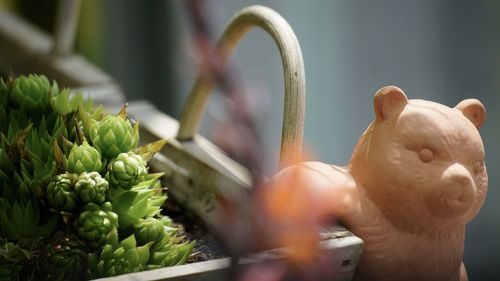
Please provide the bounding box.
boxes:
[47,174,78,211]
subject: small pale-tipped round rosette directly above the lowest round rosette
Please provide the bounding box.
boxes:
[75,172,108,204]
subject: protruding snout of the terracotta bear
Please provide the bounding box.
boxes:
[441,163,476,212]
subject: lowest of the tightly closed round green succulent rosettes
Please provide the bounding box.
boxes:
[75,202,118,245]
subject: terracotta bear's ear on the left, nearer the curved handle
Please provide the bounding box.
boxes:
[373,86,408,120]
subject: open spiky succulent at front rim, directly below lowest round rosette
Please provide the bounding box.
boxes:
[89,235,150,278]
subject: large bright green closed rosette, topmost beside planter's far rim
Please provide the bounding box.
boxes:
[90,112,139,159]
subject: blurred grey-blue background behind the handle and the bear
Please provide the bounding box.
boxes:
[4,0,500,280]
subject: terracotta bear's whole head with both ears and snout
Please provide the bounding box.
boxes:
[349,86,488,231]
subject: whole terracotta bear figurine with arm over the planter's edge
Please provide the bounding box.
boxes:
[271,86,488,281]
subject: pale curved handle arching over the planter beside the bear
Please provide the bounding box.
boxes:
[177,6,305,167]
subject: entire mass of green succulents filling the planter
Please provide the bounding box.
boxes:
[0,75,192,281]
